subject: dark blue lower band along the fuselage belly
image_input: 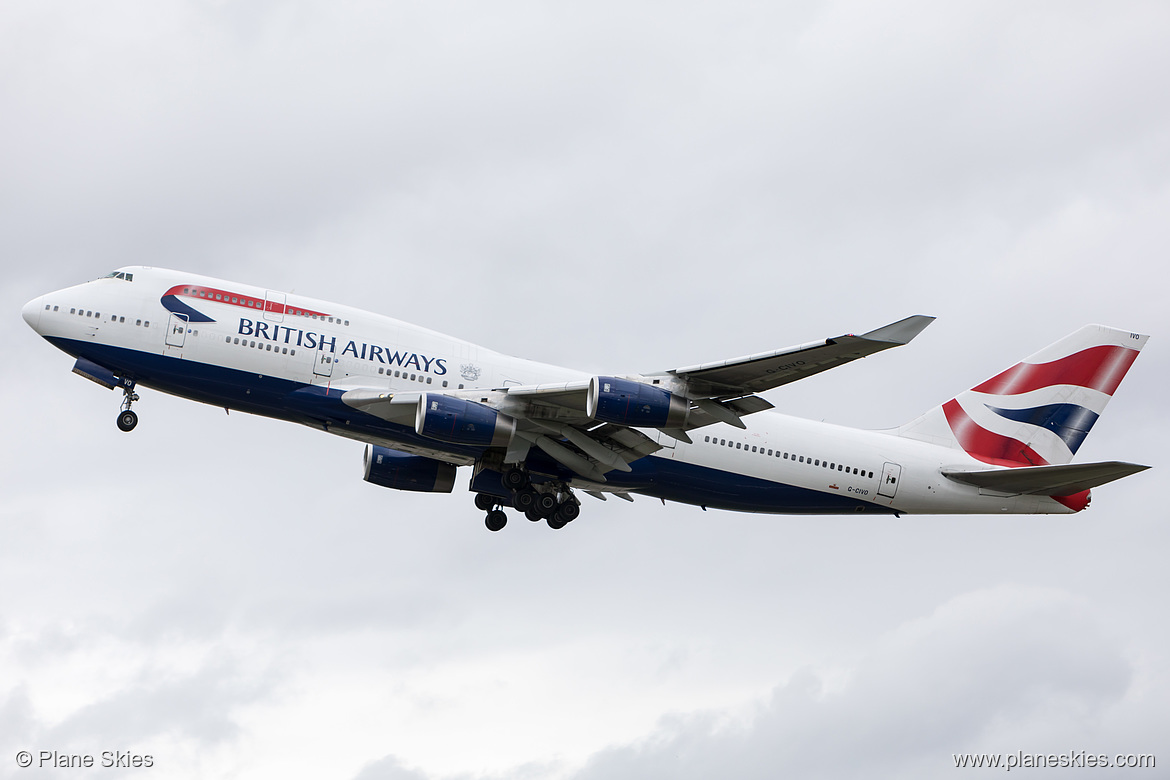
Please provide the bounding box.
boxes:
[47,337,894,515]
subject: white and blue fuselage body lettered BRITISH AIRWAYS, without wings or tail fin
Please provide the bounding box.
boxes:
[23,267,1072,513]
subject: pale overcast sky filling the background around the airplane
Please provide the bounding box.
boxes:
[0,0,1170,780]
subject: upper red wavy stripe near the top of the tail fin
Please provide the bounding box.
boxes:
[971,345,1137,395]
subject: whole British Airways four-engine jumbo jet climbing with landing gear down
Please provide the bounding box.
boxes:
[22,267,1149,531]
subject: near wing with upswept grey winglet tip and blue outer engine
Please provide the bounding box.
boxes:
[343,316,934,483]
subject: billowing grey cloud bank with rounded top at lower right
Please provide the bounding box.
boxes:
[574,587,1131,780]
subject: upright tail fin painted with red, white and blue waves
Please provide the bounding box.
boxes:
[895,325,1149,467]
